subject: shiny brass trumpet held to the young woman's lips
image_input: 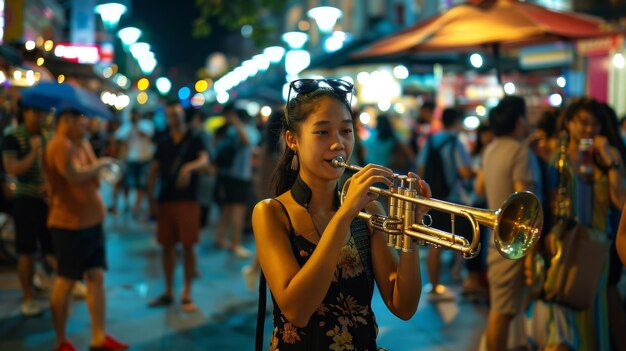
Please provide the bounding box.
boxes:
[332,156,543,260]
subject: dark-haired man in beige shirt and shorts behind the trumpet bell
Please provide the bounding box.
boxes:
[476,96,536,351]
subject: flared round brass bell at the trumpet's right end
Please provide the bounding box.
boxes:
[493,191,543,260]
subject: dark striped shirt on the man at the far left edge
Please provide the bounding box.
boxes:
[2,124,45,198]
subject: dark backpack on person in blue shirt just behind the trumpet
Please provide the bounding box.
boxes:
[424,135,457,200]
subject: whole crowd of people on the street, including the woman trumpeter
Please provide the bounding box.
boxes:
[2,79,626,350]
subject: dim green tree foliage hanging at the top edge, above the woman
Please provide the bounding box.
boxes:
[193,0,287,46]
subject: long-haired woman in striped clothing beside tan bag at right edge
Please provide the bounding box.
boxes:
[538,97,626,350]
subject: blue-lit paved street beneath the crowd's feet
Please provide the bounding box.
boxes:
[0,206,494,351]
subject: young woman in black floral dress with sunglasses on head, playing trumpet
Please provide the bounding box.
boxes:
[252,79,430,351]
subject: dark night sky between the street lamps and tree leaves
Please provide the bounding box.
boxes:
[129,0,232,82]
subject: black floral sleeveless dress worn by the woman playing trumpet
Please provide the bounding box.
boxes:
[270,178,378,351]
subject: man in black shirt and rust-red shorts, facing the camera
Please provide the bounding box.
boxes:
[148,101,209,312]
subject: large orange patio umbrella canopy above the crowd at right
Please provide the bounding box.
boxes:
[355,0,608,79]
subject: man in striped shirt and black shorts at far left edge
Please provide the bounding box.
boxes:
[2,100,56,317]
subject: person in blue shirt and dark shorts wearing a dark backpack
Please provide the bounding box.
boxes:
[417,108,474,302]
